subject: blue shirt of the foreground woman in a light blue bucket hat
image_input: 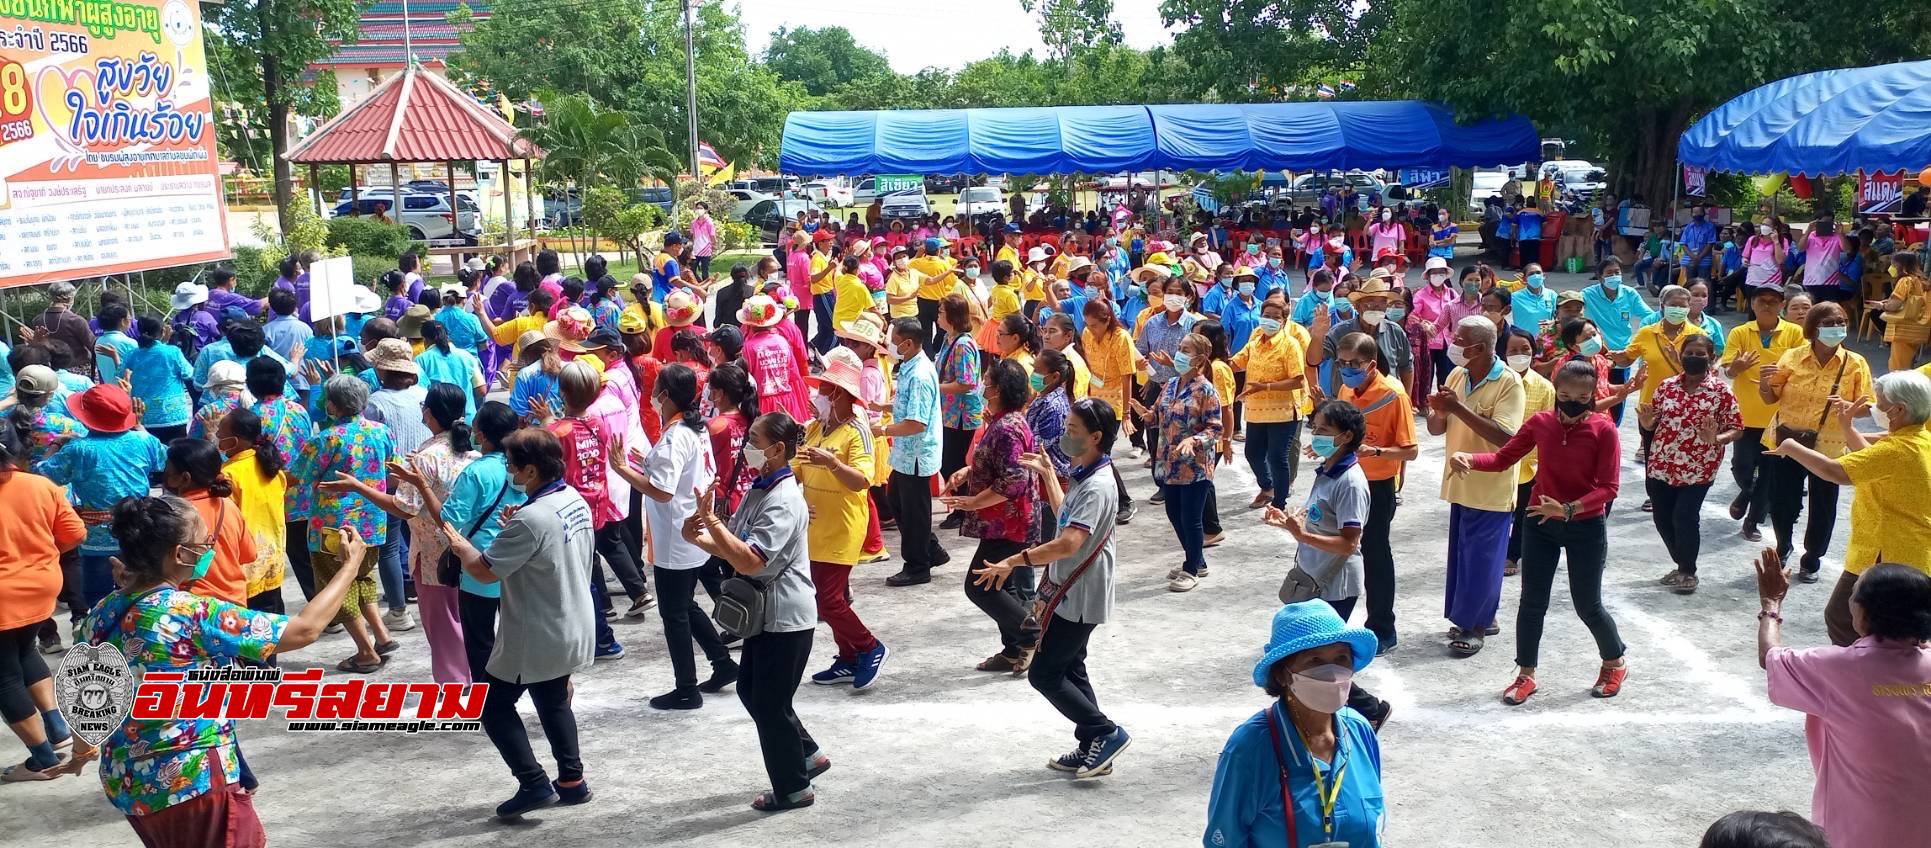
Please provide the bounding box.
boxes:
[1201,705,1388,848]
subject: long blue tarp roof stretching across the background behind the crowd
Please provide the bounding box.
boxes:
[778,100,1541,176]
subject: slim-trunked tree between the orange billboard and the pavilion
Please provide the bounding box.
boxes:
[203,0,367,232]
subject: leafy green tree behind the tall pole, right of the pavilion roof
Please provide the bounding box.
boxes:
[450,0,803,170]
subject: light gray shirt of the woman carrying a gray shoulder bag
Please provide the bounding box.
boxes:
[730,469,819,634]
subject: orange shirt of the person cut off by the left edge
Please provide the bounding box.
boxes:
[0,471,87,630]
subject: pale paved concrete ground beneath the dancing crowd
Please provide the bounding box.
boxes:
[0,268,1876,848]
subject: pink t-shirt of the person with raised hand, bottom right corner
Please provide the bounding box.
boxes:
[1765,637,1931,848]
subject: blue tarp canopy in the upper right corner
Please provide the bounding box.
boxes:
[1676,60,1931,176]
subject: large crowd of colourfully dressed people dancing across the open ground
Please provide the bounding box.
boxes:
[0,187,1931,848]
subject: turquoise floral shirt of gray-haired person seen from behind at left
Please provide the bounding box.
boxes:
[292,415,390,551]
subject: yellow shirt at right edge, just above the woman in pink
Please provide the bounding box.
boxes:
[1838,427,1931,574]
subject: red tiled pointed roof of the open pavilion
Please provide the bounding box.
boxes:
[288,68,543,164]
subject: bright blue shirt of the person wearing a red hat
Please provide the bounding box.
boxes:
[33,430,167,556]
